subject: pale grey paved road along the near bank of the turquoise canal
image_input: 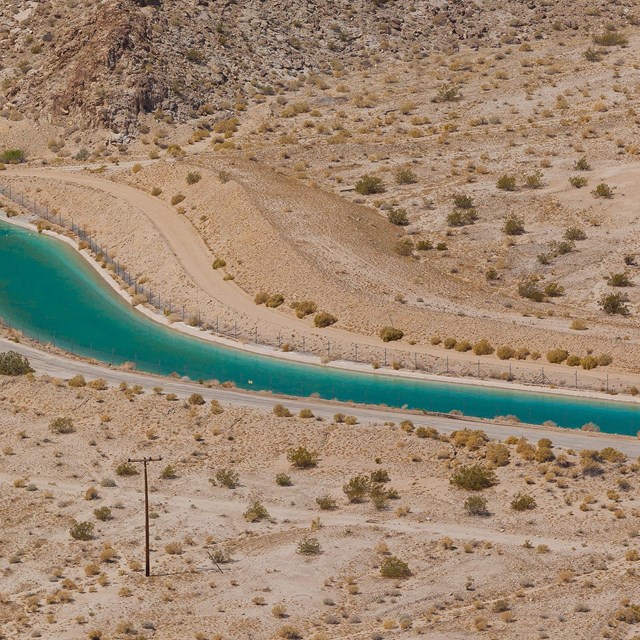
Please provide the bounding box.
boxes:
[0,338,640,457]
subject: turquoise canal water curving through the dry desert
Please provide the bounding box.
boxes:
[0,222,640,435]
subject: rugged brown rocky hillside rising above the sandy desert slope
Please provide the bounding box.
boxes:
[0,0,635,133]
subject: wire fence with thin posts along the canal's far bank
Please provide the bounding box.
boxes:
[0,184,630,394]
